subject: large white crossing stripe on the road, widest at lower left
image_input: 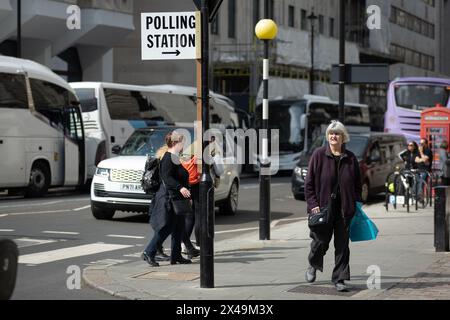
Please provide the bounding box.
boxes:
[19,243,132,265]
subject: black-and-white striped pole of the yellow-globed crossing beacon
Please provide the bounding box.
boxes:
[259,0,270,240]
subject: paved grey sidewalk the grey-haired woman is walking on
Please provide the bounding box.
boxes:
[83,204,450,300]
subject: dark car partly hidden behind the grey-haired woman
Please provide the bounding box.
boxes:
[292,132,406,202]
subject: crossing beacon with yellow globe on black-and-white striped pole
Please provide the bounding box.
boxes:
[255,19,278,240]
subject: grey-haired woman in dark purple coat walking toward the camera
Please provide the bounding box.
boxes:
[305,121,361,292]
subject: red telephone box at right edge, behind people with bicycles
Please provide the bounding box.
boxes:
[420,106,450,169]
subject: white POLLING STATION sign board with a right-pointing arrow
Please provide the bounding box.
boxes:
[141,12,198,60]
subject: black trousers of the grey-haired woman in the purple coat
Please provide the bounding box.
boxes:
[308,199,351,283]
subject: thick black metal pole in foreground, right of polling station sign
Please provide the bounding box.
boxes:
[200,0,214,288]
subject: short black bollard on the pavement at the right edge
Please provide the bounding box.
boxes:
[434,186,450,252]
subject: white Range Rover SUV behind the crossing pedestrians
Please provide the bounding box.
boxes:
[91,126,240,219]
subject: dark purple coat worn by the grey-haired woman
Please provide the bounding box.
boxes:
[305,144,362,219]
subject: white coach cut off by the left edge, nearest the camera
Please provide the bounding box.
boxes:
[0,56,86,196]
